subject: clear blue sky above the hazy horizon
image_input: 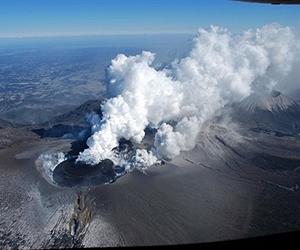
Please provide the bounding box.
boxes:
[0,0,300,37]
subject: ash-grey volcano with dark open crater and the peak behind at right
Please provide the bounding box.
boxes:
[0,92,300,248]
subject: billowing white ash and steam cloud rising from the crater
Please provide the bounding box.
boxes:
[77,24,299,167]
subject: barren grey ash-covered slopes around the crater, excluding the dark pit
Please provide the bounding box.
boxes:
[0,99,300,249]
